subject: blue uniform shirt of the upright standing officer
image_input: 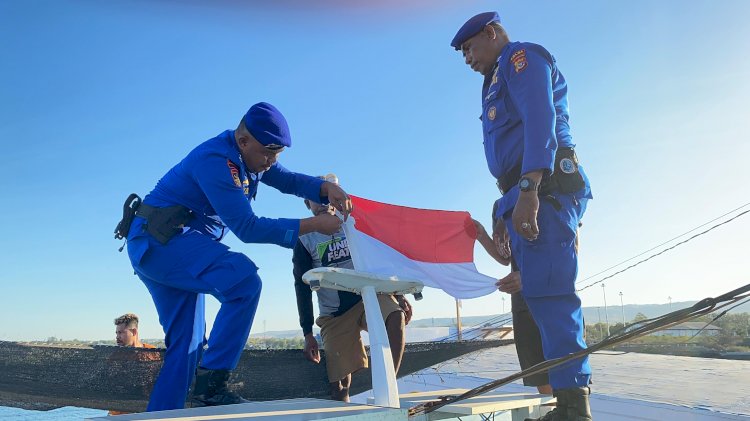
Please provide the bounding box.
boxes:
[482,42,573,178]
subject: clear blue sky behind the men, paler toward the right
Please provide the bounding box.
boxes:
[0,0,750,340]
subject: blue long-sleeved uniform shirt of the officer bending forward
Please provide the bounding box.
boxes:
[131,130,326,248]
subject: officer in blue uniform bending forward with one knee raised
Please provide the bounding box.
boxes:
[118,103,352,411]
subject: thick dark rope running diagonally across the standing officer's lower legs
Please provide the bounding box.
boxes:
[409,284,750,417]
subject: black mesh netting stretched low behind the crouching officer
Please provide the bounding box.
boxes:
[0,340,513,412]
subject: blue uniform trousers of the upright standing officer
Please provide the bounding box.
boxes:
[504,191,591,389]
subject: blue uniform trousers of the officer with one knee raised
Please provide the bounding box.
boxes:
[128,223,261,411]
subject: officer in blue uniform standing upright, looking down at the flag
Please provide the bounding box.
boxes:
[451,12,592,421]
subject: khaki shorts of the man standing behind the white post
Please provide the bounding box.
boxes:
[315,294,403,383]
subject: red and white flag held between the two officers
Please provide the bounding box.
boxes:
[344,196,497,298]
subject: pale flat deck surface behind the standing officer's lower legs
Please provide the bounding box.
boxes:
[352,347,750,421]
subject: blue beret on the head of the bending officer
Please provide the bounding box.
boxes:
[242,102,292,149]
